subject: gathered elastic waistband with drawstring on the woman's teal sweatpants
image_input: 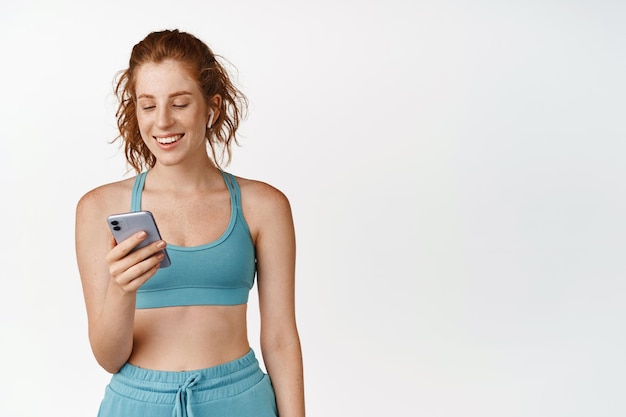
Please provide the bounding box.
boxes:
[109,349,265,416]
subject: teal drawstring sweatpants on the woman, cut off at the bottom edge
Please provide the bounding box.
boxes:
[98,350,278,417]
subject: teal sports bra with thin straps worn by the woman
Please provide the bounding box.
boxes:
[131,171,256,309]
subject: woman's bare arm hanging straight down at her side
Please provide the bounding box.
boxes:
[250,184,305,417]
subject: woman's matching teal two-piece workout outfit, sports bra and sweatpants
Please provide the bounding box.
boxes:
[98,172,278,417]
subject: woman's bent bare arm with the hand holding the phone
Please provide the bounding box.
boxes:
[75,189,164,373]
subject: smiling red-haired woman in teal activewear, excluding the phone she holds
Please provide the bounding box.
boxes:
[76,30,304,417]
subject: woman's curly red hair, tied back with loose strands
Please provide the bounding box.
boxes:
[115,29,248,173]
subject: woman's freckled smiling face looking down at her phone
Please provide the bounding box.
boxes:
[135,60,209,165]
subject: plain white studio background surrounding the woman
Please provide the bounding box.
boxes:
[0,0,626,417]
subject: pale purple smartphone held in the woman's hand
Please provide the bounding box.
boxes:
[107,211,171,268]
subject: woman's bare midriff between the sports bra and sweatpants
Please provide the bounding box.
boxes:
[128,304,250,371]
